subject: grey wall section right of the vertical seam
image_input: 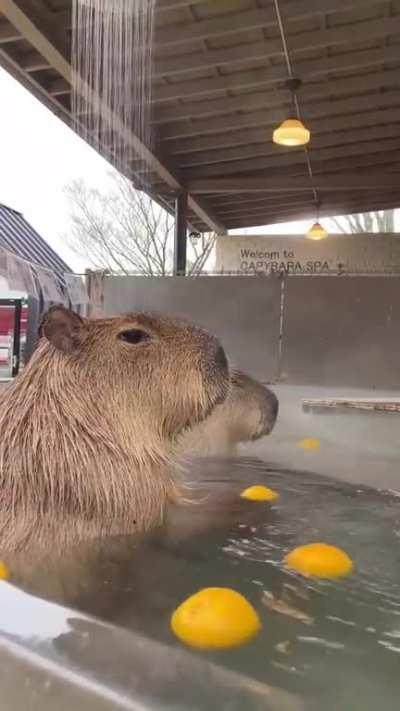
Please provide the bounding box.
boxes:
[281,276,400,389]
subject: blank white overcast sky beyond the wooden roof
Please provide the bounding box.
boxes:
[0,68,396,272]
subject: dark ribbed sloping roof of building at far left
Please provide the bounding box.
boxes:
[0,204,72,278]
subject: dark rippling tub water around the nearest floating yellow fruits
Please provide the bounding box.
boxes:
[11,464,400,711]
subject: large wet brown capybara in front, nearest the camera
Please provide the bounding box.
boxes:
[0,306,229,553]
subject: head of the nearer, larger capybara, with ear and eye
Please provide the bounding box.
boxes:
[39,306,228,437]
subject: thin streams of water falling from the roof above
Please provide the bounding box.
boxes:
[72,0,155,171]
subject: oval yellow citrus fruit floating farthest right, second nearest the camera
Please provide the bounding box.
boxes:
[284,543,353,578]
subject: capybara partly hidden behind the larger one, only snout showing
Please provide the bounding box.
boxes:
[180,371,279,457]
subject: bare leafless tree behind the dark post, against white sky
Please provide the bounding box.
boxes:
[65,173,215,276]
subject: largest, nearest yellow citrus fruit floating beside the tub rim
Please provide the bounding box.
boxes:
[171,588,261,649]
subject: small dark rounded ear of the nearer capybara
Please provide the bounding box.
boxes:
[39,305,84,353]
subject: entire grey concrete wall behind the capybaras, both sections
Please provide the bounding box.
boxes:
[103,276,400,389]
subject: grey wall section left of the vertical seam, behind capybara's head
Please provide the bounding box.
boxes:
[103,277,281,380]
